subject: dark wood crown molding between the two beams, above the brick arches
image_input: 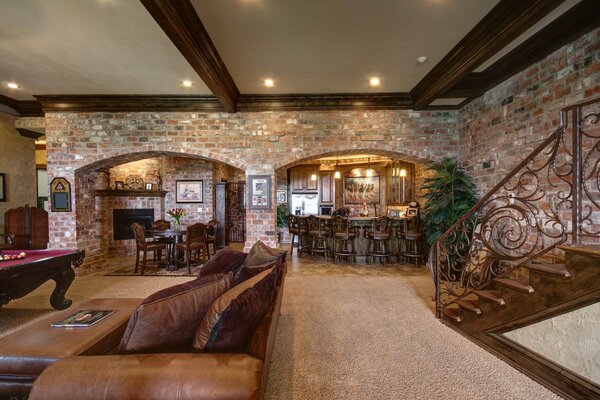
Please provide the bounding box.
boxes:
[238,93,412,111]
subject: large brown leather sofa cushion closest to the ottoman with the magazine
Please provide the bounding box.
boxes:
[119,274,233,354]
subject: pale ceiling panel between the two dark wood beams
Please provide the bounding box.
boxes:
[192,0,498,94]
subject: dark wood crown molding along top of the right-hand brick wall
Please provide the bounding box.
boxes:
[440,0,600,101]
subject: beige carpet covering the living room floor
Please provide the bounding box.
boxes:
[0,264,559,400]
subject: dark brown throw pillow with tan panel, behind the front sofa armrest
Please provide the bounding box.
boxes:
[192,266,278,353]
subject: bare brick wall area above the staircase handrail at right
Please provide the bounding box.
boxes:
[460,29,600,195]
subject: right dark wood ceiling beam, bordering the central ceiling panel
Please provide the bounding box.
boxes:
[411,0,562,109]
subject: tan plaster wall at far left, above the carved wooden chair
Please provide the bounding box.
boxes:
[0,114,37,233]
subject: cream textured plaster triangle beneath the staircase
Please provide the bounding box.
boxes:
[504,303,600,384]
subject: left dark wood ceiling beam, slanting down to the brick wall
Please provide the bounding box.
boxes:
[140,0,240,112]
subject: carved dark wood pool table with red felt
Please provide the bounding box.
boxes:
[0,250,85,310]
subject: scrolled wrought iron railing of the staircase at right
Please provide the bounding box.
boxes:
[428,99,600,317]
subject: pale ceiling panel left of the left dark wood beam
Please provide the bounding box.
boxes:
[0,0,210,100]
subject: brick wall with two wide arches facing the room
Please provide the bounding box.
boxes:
[46,110,458,266]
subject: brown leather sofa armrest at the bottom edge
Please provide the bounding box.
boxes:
[29,353,263,400]
